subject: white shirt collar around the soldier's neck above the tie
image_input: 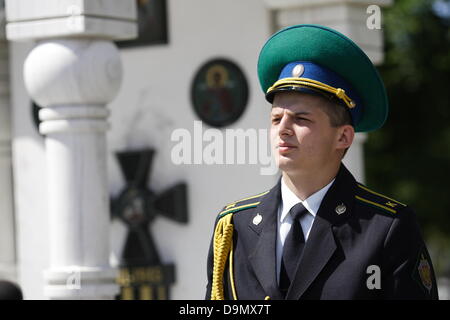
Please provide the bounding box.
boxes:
[280,177,336,222]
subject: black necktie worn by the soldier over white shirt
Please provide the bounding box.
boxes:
[280,203,308,295]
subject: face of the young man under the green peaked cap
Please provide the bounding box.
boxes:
[271,92,353,174]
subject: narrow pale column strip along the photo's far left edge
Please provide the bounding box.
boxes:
[0,3,16,281]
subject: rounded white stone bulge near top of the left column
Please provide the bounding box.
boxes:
[24,39,122,107]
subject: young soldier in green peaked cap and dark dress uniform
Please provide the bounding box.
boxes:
[206,25,437,299]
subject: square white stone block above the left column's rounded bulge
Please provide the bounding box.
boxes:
[6,0,138,41]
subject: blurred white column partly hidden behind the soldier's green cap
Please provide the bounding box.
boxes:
[265,0,392,182]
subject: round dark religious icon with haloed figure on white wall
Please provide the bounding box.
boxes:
[191,59,248,127]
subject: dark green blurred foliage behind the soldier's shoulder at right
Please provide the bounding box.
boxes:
[365,0,450,272]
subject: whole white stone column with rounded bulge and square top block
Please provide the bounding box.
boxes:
[7,0,137,299]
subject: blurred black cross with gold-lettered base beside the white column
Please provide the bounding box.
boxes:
[111,149,188,300]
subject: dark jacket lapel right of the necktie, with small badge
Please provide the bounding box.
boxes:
[286,164,356,300]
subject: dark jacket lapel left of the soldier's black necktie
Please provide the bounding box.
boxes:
[249,180,282,299]
